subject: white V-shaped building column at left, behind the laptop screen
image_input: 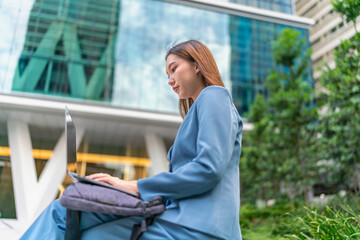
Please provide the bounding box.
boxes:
[7,120,85,230]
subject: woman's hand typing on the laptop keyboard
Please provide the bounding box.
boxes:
[87,173,139,194]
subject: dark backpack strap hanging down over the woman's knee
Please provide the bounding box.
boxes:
[65,208,81,240]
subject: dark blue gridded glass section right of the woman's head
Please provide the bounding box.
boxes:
[229,16,313,114]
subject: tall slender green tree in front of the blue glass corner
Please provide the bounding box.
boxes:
[266,29,317,206]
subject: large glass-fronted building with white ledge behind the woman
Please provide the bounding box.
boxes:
[0,0,312,236]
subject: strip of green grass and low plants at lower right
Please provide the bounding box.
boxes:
[240,196,360,240]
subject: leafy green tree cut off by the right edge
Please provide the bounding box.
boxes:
[319,0,360,193]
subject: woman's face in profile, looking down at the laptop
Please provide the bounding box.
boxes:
[166,54,205,101]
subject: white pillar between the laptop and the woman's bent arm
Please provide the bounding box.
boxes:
[145,133,169,175]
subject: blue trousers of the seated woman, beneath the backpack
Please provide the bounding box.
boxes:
[20,200,216,240]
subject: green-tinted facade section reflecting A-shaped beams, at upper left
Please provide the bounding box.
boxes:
[12,0,120,101]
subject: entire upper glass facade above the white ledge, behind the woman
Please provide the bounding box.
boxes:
[0,0,311,114]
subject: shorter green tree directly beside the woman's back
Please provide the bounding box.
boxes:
[240,94,279,202]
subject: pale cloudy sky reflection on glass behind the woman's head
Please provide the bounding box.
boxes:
[112,0,231,113]
